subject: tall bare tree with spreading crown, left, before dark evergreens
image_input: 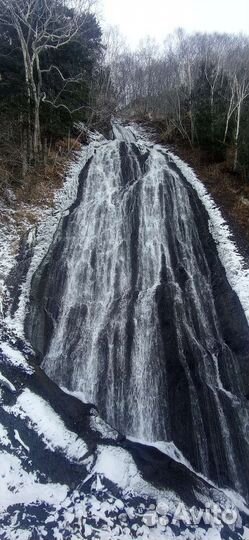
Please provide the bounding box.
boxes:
[0,0,94,155]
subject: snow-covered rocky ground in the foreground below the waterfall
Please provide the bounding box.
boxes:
[0,345,248,540]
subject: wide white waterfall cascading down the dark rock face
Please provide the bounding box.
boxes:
[26,126,249,493]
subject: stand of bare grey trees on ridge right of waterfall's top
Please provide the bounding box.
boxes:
[107,29,249,171]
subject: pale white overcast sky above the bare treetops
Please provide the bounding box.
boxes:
[101,0,249,47]
